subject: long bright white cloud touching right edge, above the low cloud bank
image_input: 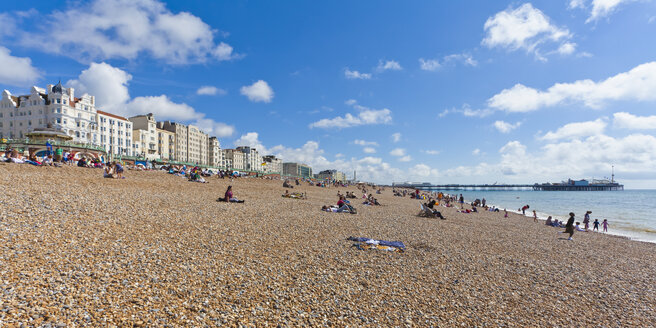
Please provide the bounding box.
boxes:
[488,62,656,112]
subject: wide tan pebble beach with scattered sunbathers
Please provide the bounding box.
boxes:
[0,163,656,327]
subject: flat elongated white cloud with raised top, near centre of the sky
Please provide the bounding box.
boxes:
[309,102,392,129]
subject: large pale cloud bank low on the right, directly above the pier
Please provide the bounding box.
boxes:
[441,134,656,183]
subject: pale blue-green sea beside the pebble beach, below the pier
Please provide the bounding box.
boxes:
[432,190,656,243]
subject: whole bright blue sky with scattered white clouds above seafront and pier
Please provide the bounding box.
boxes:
[0,0,656,188]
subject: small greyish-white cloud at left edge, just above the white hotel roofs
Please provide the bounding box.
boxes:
[0,46,41,87]
